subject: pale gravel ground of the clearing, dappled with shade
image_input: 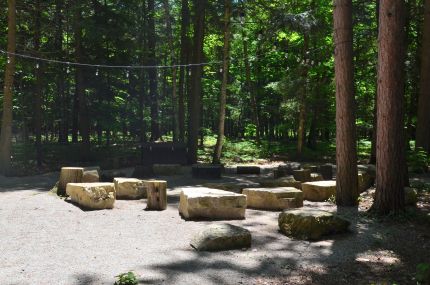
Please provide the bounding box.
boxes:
[0,164,430,285]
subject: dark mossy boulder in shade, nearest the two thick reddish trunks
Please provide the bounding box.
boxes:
[278,209,350,240]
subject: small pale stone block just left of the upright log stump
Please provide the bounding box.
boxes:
[113,178,146,199]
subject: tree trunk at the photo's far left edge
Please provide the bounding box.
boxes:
[0,0,16,174]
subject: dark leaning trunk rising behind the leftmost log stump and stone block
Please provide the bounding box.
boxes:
[75,1,90,152]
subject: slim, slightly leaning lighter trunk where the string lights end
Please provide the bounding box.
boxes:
[212,0,231,164]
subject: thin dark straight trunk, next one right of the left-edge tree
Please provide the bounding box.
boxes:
[33,0,43,167]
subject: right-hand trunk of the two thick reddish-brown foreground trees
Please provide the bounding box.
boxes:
[372,0,406,214]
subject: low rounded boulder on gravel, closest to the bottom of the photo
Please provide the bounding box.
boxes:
[191,224,252,251]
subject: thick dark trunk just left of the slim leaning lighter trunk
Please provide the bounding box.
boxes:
[188,0,207,164]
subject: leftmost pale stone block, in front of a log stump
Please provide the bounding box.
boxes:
[66,183,115,210]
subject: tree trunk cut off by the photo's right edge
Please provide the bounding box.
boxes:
[416,0,430,152]
